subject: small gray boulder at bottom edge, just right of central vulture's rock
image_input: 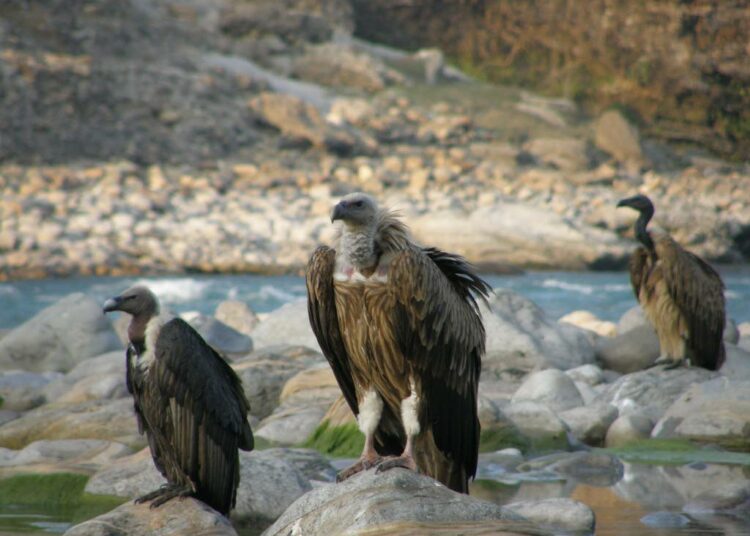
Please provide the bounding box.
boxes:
[505,498,596,534]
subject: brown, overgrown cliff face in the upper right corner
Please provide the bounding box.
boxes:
[353,0,750,159]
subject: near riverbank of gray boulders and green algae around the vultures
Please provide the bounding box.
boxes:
[0,289,750,536]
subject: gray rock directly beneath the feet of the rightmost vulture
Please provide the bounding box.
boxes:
[596,367,718,420]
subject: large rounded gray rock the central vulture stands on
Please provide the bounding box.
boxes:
[263,469,544,536]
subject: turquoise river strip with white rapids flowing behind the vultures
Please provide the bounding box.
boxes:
[0,266,750,329]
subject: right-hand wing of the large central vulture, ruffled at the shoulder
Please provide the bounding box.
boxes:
[388,248,489,482]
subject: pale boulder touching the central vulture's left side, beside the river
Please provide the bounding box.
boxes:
[252,300,322,354]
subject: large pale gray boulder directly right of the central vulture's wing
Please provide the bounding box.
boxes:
[482,289,594,374]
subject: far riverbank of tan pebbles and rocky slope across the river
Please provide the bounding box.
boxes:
[0,0,750,279]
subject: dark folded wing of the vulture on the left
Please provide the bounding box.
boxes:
[152,318,253,514]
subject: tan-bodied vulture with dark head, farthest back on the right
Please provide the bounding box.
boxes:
[617,195,725,370]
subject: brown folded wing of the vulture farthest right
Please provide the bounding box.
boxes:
[655,237,725,370]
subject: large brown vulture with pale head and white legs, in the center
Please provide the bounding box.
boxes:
[306,193,491,493]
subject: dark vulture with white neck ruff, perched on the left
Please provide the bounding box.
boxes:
[104,286,253,515]
